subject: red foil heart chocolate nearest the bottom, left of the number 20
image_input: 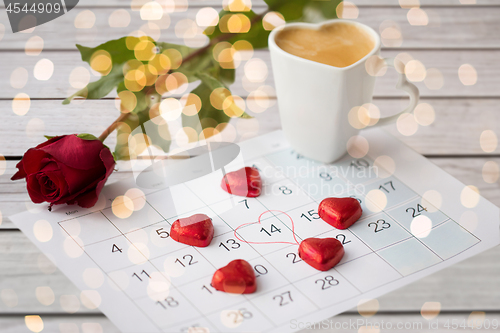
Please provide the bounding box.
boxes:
[212,259,257,294]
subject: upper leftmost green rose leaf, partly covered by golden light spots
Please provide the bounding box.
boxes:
[76,36,139,67]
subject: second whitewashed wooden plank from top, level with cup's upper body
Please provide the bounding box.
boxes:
[0,50,500,99]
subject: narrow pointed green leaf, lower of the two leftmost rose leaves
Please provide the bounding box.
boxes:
[63,65,123,105]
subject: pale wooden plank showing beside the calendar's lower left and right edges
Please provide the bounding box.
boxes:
[0,227,500,314]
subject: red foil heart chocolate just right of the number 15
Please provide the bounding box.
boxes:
[318,197,363,229]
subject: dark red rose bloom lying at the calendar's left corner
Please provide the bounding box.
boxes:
[11,134,115,208]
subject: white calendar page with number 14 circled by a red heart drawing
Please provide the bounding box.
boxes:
[12,129,499,332]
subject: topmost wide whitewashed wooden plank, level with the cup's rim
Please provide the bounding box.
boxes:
[0,6,500,50]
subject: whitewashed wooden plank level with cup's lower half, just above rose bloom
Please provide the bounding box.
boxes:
[0,98,500,156]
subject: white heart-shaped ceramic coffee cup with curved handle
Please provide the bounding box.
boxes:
[269,19,419,163]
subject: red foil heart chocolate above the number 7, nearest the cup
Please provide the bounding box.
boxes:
[221,167,262,198]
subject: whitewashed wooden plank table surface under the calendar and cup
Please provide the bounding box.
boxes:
[0,0,500,333]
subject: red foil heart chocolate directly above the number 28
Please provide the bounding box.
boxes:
[299,238,344,271]
